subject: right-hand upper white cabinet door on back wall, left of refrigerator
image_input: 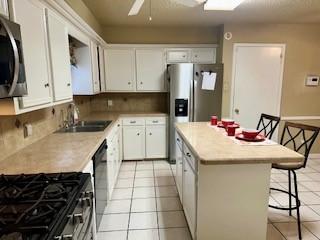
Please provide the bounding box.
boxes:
[136,49,165,91]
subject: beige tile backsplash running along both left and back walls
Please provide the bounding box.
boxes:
[0,93,167,161]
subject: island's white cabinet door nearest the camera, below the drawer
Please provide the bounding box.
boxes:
[182,158,197,239]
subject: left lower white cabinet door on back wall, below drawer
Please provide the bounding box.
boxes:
[123,126,145,160]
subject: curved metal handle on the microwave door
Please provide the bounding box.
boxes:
[0,18,20,96]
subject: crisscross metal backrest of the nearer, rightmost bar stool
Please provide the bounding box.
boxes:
[280,122,320,167]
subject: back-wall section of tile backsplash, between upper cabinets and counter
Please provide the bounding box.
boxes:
[91,93,168,113]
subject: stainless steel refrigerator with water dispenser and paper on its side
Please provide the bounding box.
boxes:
[168,63,223,162]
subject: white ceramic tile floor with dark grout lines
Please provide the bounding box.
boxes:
[98,159,320,240]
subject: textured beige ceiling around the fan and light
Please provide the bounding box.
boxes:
[83,0,320,26]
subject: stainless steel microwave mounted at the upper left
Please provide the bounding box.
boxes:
[0,17,28,98]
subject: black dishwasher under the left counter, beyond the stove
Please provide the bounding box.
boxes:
[92,140,108,231]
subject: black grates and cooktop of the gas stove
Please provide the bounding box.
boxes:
[0,173,88,240]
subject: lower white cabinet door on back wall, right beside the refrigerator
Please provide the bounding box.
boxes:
[146,125,167,158]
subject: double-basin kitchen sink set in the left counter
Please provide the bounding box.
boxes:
[57,121,112,133]
